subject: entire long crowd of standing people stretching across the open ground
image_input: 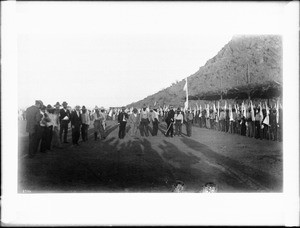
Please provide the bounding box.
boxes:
[24,100,282,158]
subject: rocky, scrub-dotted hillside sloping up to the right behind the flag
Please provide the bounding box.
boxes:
[128,35,282,107]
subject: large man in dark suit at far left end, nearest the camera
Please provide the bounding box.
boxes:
[26,100,43,158]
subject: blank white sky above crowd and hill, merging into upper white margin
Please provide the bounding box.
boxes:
[16,2,284,108]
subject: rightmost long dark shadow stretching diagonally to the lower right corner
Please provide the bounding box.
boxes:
[181,137,283,192]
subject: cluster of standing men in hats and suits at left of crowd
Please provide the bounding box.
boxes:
[24,100,106,158]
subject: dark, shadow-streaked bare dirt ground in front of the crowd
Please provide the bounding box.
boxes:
[18,121,283,193]
